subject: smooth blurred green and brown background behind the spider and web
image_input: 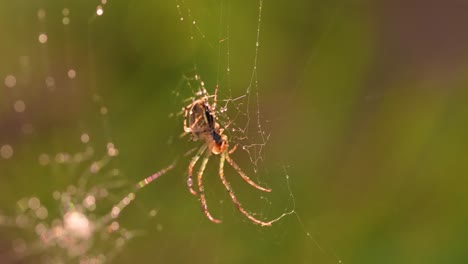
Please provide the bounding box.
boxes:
[0,0,468,263]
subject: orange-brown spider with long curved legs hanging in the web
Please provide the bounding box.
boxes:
[184,86,274,226]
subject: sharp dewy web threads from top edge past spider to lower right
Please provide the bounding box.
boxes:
[174,0,341,263]
